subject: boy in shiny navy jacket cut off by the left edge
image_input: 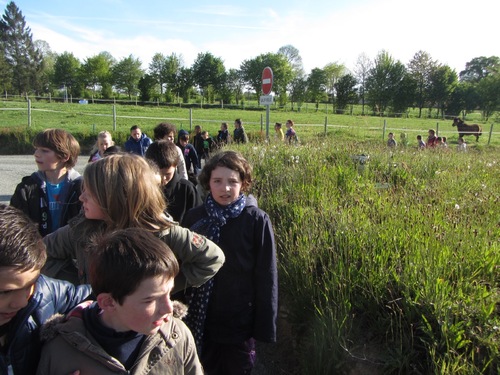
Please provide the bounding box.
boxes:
[0,204,91,375]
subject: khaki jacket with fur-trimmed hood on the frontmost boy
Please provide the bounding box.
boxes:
[37,301,203,375]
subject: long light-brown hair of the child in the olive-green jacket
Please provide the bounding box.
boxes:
[83,154,172,232]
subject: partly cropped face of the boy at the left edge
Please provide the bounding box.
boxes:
[0,267,40,326]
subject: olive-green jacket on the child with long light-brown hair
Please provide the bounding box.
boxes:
[42,216,225,294]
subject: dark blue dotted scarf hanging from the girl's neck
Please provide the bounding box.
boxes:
[184,193,246,355]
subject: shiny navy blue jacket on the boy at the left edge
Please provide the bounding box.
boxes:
[0,275,91,375]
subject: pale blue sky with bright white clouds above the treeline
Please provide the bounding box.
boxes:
[0,0,500,74]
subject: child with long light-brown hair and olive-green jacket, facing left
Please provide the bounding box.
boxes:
[44,154,224,290]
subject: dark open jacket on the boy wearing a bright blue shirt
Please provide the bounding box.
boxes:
[10,169,82,236]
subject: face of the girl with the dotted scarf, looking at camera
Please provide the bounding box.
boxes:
[210,167,242,206]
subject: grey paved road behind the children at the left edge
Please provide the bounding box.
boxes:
[0,155,89,203]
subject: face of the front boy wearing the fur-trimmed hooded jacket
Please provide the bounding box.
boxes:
[104,276,174,335]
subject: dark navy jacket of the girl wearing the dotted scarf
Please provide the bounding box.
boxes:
[182,195,278,344]
